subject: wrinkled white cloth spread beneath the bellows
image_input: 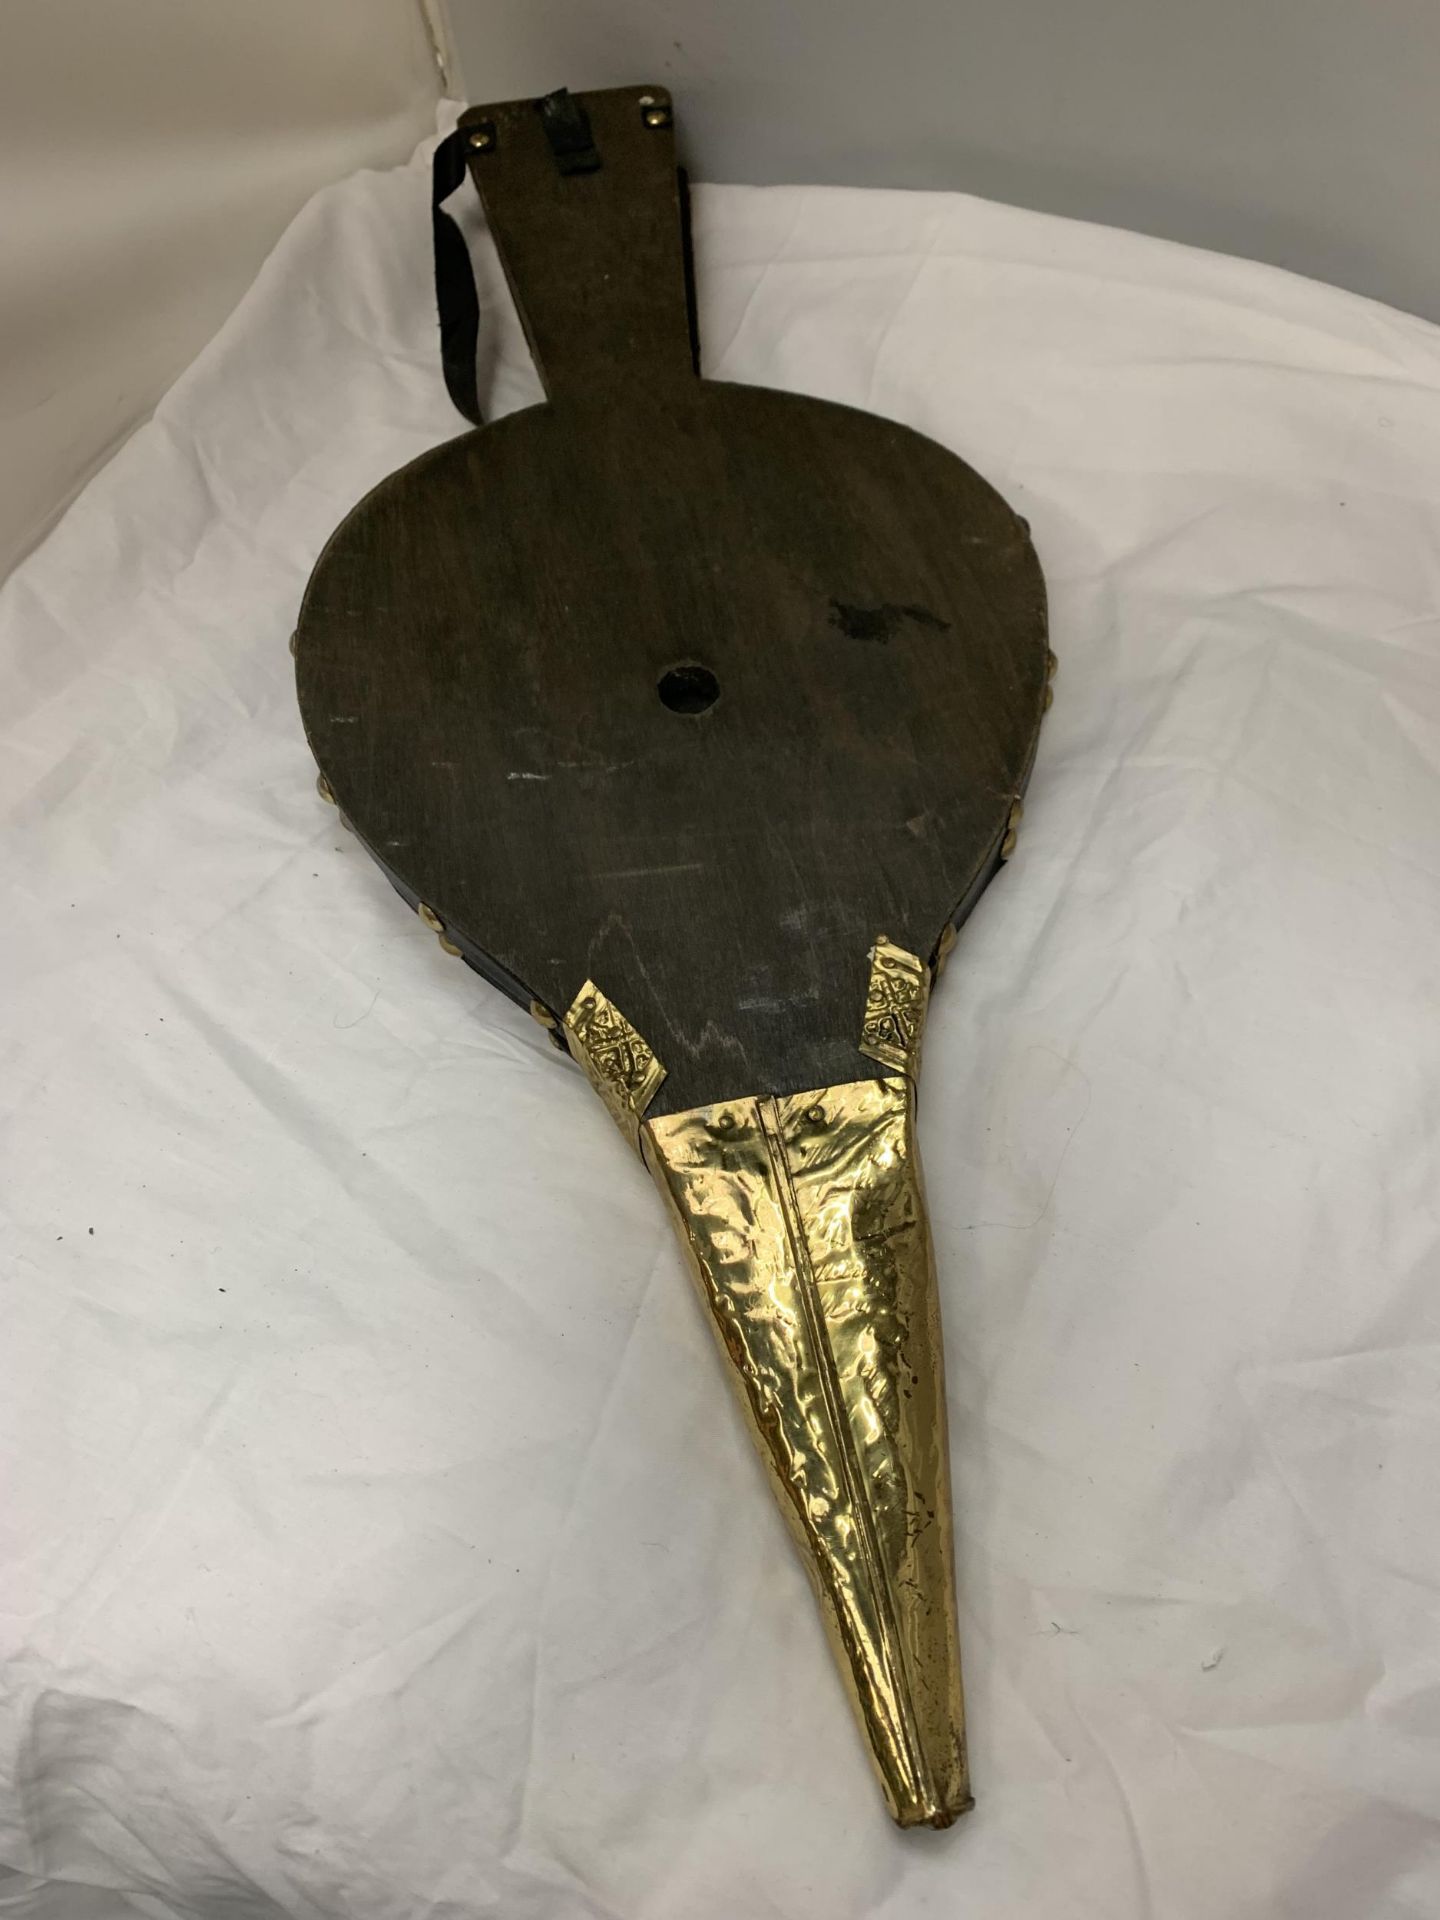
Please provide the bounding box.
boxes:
[0,108,1440,1920]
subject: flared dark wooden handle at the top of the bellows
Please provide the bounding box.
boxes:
[459,86,697,397]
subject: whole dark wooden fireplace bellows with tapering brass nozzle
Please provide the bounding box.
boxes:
[298,88,1048,1824]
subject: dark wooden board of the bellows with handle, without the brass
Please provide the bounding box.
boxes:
[298,88,1046,1112]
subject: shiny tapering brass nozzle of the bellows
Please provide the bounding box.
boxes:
[641,1082,972,1826]
